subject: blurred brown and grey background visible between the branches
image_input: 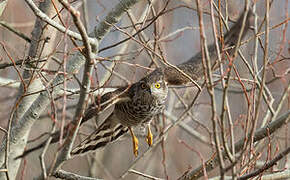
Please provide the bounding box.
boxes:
[0,0,290,179]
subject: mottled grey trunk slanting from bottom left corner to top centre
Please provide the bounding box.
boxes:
[0,0,139,179]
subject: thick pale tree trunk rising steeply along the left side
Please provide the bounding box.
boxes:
[0,1,57,179]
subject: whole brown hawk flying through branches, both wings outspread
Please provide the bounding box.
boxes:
[20,10,253,157]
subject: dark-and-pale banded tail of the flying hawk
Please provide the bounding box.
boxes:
[71,113,128,155]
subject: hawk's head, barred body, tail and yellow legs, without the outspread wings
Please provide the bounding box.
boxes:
[71,71,168,156]
